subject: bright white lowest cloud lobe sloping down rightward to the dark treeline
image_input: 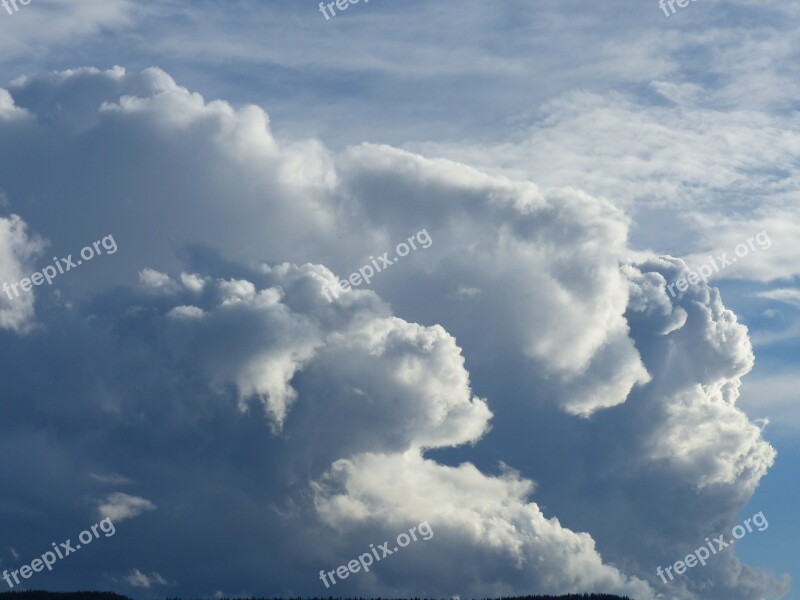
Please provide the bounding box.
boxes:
[315,451,656,600]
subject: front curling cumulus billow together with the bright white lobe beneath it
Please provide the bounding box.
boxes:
[69,265,654,598]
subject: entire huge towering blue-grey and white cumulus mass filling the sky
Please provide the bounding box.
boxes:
[0,69,782,600]
